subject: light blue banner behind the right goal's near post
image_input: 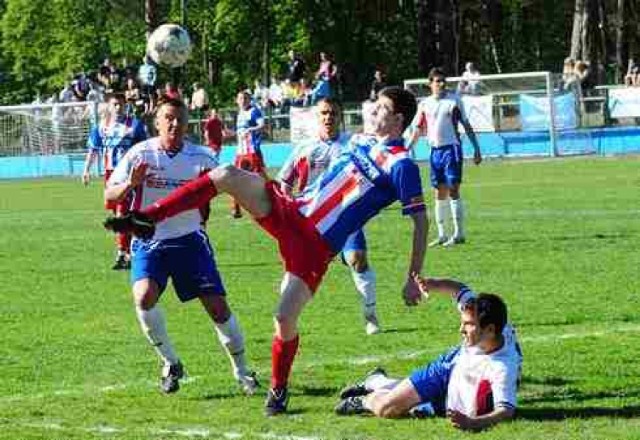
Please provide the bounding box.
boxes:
[520,93,578,131]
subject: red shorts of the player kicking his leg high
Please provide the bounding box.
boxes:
[256,181,335,292]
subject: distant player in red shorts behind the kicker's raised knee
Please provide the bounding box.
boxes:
[231,91,264,218]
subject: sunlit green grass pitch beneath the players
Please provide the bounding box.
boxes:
[0,157,640,440]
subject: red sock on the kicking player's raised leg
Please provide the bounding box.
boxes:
[141,174,218,222]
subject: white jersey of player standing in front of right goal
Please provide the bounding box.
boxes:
[412,91,467,148]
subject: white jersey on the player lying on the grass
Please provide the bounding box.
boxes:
[447,288,522,417]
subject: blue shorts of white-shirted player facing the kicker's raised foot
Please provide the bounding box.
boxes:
[131,231,225,302]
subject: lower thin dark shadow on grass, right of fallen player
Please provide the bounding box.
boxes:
[516,405,640,421]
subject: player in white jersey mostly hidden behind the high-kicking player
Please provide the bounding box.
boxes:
[278,98,380,335]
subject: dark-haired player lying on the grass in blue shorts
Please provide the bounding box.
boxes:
[336,276,522,430]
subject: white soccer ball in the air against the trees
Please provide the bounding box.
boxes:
[147,24,191,67]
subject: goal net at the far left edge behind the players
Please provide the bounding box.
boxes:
[0,102,98,157]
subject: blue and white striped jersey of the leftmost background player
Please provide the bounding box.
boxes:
[87,116,147,171]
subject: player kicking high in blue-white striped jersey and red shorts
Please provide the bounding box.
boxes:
[105,87,428,416]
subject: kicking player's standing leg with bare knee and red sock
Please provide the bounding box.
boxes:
[265,272,312,416]
